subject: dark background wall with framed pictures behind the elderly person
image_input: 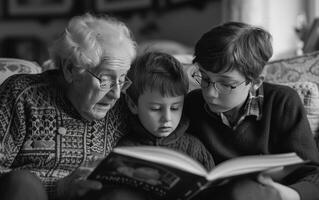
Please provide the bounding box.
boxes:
[0,0,222,63]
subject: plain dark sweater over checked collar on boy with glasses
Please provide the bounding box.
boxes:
[184,83,319,200]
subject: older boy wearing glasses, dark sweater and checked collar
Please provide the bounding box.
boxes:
[185,22,319,200]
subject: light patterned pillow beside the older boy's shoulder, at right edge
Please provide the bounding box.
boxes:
[279,81,319,135]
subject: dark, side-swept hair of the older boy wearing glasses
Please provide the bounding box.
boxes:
[193,22,273,81]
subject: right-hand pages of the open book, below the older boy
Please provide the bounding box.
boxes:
[207,153,305,181]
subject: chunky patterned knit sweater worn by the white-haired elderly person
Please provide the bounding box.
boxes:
[0,70,129,199]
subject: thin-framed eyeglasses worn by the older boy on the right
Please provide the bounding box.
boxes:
[192,72,247,94]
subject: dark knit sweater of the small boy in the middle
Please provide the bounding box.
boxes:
[118,116,215,169]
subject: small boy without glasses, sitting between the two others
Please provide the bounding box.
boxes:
[119,52,214,169]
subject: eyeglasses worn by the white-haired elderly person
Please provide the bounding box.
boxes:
[85,70,132,91]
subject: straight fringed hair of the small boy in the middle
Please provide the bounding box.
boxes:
[127,51,189,103]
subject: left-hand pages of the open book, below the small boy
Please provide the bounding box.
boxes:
[113,146,207,176]
